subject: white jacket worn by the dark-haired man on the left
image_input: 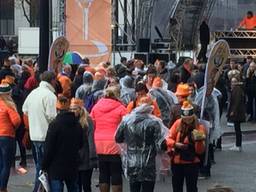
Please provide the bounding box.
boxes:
[22,81,57,141]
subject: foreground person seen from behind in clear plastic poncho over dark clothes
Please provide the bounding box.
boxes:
[115,97,168,192]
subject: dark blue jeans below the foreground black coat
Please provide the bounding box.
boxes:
[50,180,79,192]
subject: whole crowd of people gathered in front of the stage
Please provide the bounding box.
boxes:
[0,53,251,192]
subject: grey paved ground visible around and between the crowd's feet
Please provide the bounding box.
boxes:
[9,133,256,192]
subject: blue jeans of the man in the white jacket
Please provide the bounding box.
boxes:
[33,141,44,192]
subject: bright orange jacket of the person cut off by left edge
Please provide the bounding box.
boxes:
[0,100,21,137]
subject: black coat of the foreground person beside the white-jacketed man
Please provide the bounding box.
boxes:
[42,112,84,180]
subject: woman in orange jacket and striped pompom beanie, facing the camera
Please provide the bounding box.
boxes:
[166,101,205,192]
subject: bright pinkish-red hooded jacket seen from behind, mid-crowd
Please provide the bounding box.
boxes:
[91,98,127,155]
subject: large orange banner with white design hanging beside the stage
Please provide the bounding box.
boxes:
[66,0,111,65]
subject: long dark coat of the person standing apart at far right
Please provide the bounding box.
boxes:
[227,84,246,122]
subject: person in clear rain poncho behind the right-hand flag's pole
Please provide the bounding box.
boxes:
[194,87,222,178]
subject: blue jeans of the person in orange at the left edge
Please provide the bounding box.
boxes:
[0,137,15,190]
